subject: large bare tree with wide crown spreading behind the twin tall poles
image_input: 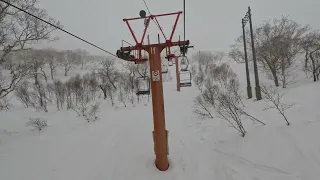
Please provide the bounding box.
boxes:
[229,16,309,88]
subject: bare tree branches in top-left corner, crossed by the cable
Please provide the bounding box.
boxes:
[0,0,61,64]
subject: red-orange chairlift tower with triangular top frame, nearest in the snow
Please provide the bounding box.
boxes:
[117,10,189,171]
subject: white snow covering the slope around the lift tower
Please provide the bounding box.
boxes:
[0,58,320,180]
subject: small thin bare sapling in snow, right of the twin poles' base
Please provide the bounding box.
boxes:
[261,85,294,126]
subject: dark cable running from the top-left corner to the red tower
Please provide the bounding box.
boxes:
[0,0,117,57]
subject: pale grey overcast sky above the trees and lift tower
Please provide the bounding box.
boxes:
[39,0,320,55]
